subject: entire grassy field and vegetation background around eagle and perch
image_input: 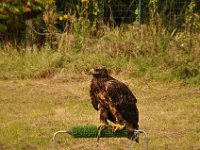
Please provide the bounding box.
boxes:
[0,0,200,150]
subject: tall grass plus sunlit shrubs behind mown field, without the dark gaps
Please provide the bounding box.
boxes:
[0,1,200,86]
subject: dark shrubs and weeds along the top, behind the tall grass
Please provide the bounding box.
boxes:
[0,0,200,43]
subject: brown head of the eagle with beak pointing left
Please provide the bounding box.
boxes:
[89,66,109,78]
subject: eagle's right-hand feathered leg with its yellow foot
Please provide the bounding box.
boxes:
[109,102,126,132]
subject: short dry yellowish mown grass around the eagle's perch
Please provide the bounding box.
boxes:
[0,74,200,150]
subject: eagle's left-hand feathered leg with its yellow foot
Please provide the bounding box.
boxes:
[98,107,108,130]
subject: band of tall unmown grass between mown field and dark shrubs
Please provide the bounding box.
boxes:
[0,23,200,85]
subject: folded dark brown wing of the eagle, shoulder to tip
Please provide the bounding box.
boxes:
[105,80,139,129]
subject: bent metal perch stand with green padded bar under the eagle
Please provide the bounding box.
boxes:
[52,126,148,150]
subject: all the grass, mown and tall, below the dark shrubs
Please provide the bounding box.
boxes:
[0,19,200,150]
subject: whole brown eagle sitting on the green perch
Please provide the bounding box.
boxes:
[90,66,139,140]
